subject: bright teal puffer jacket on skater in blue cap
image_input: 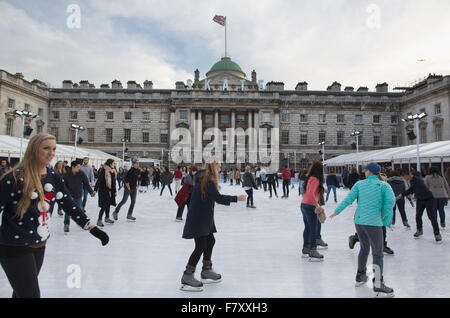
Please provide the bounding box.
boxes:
[335,175,395,227]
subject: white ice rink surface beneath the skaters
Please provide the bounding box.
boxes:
[0,183,450,298]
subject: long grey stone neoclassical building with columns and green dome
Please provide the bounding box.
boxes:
[0,57,450,169]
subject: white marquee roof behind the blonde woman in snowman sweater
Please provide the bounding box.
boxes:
[0,135,122,167]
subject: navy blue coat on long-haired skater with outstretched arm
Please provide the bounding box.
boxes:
[183,170,237,239]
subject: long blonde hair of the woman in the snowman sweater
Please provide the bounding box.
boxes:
[12,134,56,219]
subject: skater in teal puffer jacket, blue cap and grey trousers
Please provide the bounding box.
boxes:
[330,163,395,297]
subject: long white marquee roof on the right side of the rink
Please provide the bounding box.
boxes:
[325,140,450,167]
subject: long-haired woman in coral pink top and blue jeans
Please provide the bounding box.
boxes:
[300,161,324,261]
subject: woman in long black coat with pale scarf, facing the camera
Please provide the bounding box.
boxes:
[94,159,117,227]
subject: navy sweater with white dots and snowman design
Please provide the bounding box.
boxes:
[0,168,90,245]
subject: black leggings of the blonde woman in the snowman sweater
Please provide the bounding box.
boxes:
[0,245,45,298]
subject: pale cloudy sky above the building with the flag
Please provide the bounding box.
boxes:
[0,0,450,90]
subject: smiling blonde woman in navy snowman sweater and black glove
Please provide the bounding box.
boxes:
[0,134,109,298]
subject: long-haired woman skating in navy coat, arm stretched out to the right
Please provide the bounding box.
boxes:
[181,157,246,291]
